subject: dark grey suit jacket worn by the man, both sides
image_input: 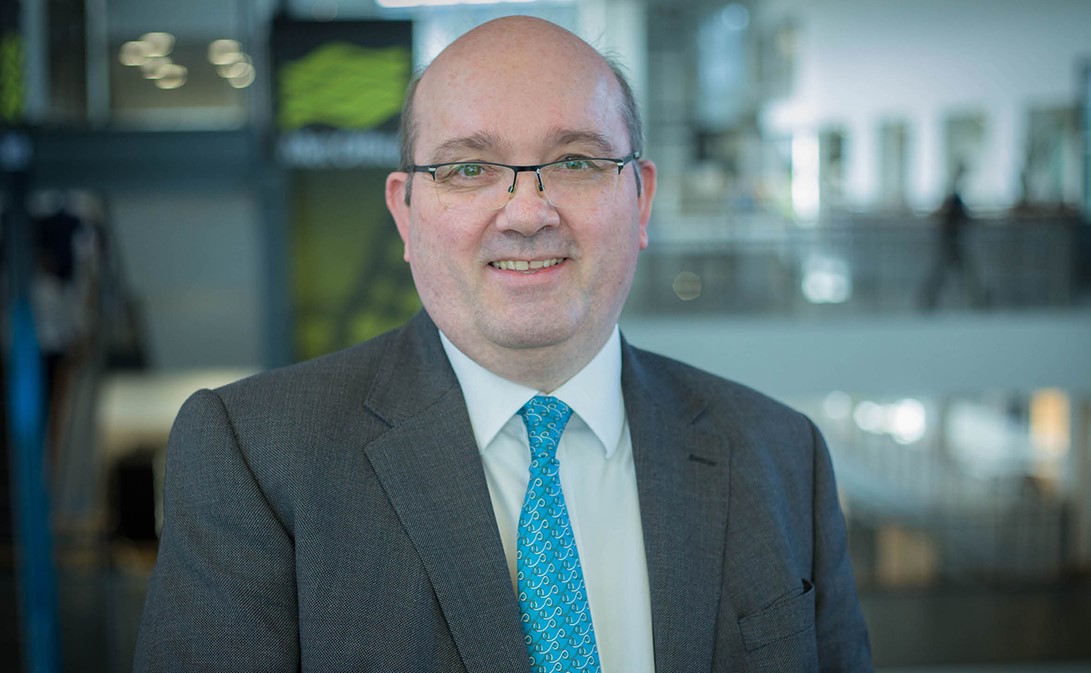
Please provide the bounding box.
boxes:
[135,313,871,673]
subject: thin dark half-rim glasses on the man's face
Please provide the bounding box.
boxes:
[408,152,640,211]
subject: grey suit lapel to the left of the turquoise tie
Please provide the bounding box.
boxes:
[365,314,527,673]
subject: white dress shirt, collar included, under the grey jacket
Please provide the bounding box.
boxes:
[440,327,655,673]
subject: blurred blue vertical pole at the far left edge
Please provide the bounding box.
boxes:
[0,130,60,673]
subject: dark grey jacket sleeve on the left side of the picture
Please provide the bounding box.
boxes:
[134,390,299,673]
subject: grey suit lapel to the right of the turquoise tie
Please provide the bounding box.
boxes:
[622,344,729,673]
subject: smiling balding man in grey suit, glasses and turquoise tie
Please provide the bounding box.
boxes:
[136,17,871,673]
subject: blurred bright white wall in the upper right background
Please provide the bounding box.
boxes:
[756,0,1091,208]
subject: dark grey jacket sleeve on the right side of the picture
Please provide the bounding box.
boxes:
[811,416,873,673]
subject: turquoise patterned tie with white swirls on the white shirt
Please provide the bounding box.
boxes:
[516,396,599,673]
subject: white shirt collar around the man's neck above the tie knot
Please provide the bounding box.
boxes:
[440,326,625,458]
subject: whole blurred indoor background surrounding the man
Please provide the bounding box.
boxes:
[0,0,1091,673]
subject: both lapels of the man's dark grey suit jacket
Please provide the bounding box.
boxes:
[364,312,729,673]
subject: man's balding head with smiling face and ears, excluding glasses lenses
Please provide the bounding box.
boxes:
[386,16,656,390]
